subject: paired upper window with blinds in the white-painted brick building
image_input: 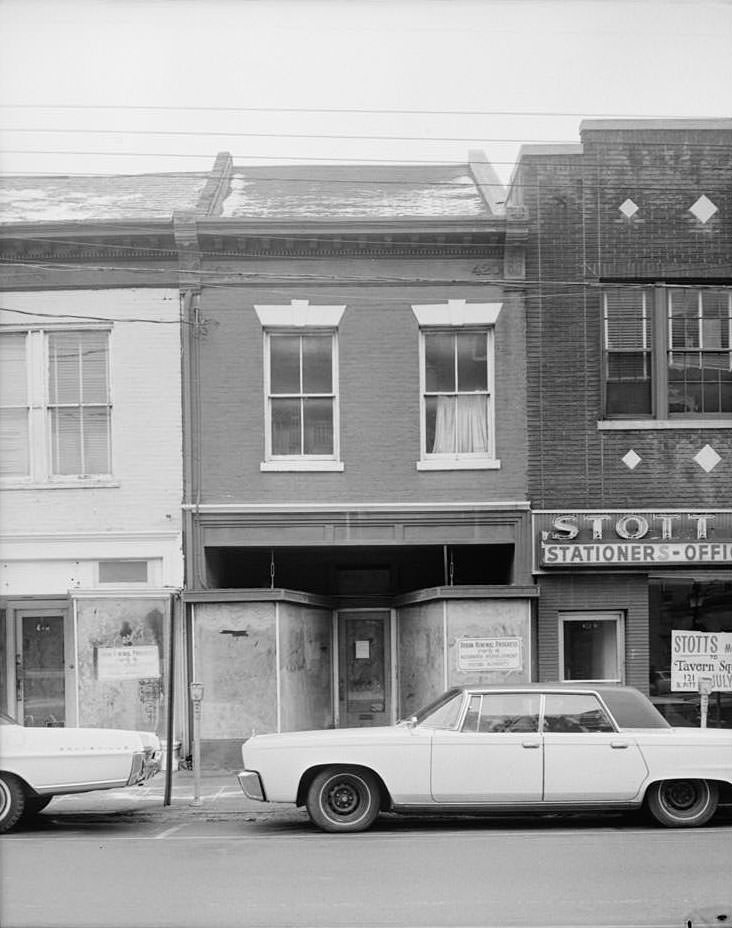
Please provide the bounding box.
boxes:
[0,330,112,483]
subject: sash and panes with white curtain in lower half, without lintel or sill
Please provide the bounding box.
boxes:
[422,329,493,457]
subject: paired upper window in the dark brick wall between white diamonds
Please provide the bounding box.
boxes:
[603,287,732,420]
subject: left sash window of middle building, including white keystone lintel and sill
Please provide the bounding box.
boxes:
[255,300,345,471]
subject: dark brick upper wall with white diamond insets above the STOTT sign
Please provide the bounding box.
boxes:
[515,124,732,508]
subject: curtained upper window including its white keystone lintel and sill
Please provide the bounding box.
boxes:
[412,300,501,470]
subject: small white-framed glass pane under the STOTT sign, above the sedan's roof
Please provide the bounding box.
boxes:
[559,612,625,683]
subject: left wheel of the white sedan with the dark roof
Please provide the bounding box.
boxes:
[306,767,381,832]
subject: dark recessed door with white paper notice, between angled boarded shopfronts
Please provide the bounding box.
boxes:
[338,609,392,728]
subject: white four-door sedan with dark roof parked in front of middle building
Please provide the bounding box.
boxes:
[238,683,732,832]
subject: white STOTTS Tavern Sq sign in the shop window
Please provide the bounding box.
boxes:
[671,631,732,693]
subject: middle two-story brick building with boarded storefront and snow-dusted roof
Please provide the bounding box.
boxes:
[185,150,536,760]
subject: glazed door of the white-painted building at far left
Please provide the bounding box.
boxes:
[15,609,66,727]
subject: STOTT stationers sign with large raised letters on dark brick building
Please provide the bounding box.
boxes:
[534,509,732,568]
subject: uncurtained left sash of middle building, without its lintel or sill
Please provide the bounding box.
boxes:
[267,332,336,459]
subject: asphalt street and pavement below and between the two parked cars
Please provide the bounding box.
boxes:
[0,771,732,928]
